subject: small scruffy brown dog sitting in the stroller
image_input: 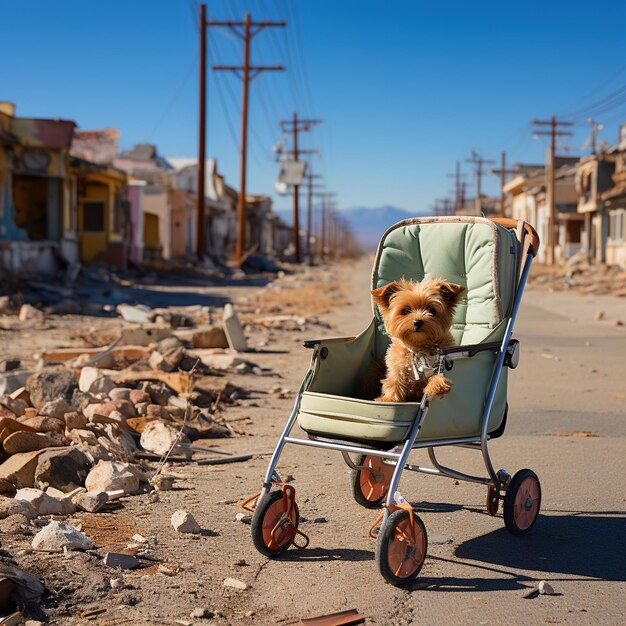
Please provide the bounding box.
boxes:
[372,278,465,402]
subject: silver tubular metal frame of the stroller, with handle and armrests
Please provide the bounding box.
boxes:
[246,218,540,585]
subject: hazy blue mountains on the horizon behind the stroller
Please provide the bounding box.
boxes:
[275,204,428,251]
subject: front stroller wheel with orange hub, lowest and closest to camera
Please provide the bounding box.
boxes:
[376,509,428,587]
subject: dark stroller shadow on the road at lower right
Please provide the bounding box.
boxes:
[455,512,626,581]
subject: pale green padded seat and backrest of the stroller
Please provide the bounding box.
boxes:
[298,217,521,448]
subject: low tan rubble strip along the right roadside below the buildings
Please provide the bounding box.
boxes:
[529,253,626,298]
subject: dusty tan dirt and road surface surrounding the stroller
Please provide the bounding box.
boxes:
[0,259,626,626]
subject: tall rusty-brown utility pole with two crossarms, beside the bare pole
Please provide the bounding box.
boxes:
[205,10,286,265]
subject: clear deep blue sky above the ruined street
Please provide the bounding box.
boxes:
[0,0,626,211]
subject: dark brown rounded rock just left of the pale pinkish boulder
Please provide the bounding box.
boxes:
[35,447,91,493]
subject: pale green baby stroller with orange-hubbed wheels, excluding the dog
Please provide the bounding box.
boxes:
[244,217,541,586]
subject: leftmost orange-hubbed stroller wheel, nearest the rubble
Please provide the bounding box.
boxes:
[251,490,300,558]
